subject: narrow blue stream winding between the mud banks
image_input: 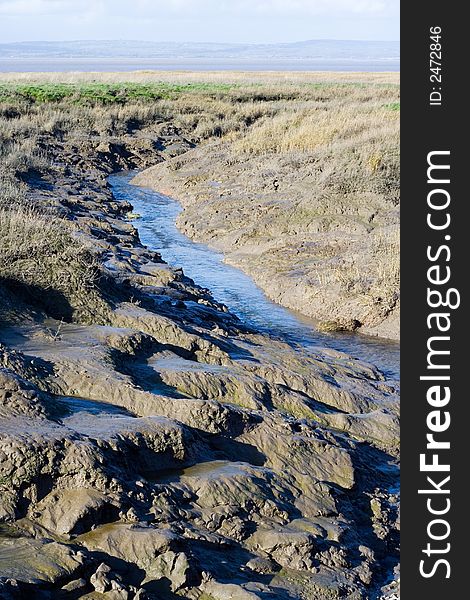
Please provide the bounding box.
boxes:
[109,173,400,380]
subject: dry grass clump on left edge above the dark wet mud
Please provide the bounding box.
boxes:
[0,205,106,320]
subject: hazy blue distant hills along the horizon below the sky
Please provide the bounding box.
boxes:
[0,40,399,61]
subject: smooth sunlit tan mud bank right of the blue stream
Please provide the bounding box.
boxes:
[134,117,400,340]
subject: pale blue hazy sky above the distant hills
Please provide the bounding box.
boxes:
[0,0,400,43]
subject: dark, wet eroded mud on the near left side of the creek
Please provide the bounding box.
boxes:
[0,125,398,600]
